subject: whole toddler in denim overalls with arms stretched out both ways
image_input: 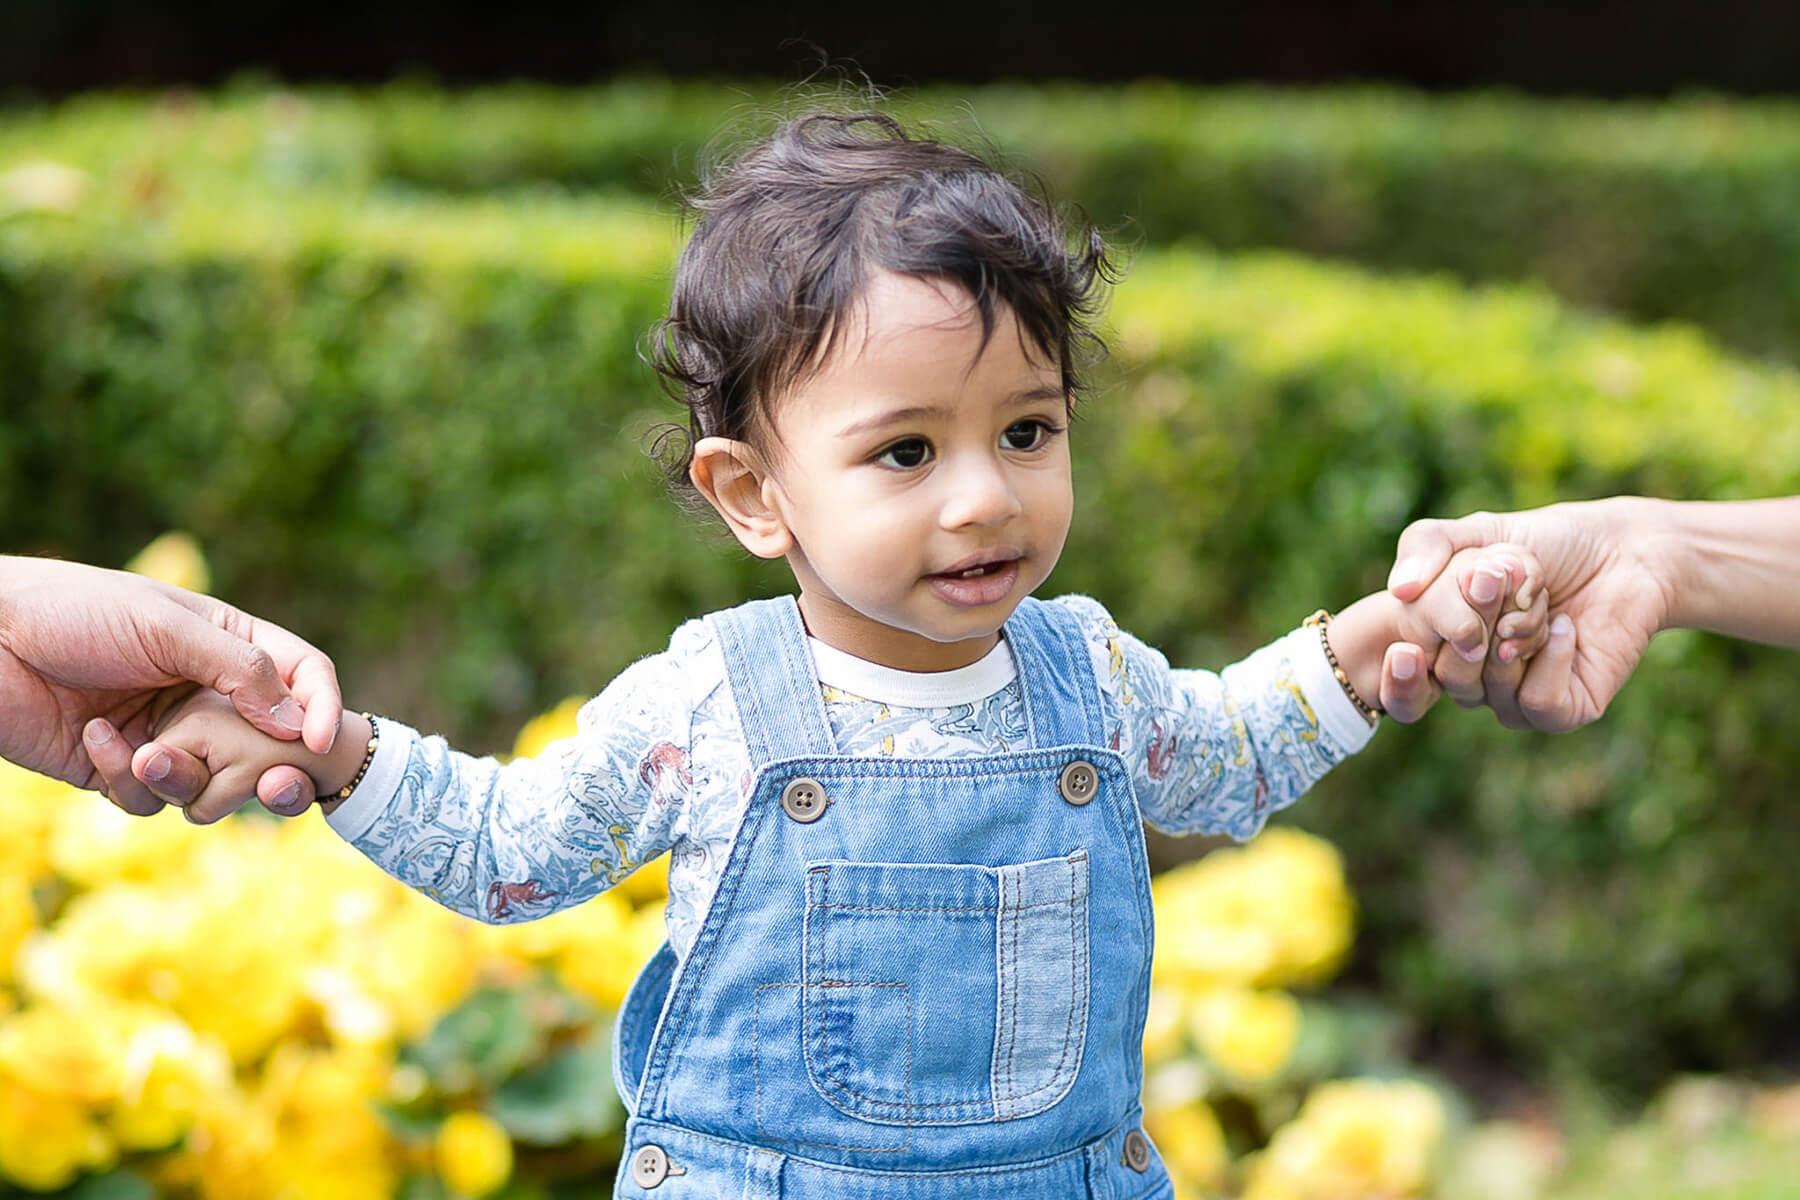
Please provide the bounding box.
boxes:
[144,113,1546,1200]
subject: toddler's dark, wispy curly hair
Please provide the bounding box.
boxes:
[650,112,1112,502]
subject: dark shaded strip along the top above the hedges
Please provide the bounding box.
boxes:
[10,0,1800,95]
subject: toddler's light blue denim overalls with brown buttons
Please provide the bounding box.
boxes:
[614,597,1174,1200]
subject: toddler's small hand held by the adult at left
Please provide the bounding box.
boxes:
[139,687,369,824]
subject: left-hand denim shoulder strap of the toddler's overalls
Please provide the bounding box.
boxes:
[706,596,837,766]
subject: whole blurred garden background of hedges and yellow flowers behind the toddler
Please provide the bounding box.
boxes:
[0,0,1800,1200]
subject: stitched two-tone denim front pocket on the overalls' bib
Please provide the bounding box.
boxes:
[801,851,1089,1124]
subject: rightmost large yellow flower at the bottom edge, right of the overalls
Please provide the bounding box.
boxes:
[1244,1079,1445,1200]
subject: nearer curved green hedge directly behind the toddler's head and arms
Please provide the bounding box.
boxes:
[0,154,1800,1087]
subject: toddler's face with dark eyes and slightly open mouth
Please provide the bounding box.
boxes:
[767,273,1075,671]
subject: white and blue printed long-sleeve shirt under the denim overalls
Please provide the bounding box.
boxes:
[329,596,1373,957]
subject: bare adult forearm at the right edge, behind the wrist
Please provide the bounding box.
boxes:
[1645,497,1800,646]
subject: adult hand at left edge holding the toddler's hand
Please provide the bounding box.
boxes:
[0,556,344,815]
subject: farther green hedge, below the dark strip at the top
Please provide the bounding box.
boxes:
[0,79,1800,360]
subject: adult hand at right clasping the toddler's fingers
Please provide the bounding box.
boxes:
[1388,498,1672,732]
